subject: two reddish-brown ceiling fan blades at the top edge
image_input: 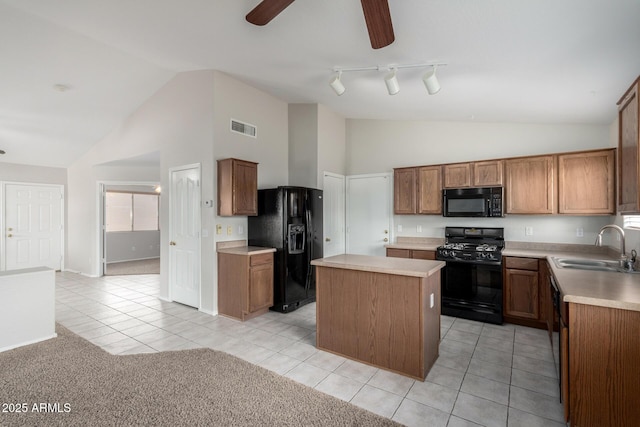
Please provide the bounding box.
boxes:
[246,0,395,49]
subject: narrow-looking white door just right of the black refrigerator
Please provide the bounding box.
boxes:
[322,172,346,257]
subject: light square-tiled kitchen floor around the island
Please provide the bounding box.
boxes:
[56,272,565,427]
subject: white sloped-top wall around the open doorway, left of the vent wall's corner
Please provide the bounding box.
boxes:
[66,71,213,297]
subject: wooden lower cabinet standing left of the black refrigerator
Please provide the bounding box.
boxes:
[218,252,273,321]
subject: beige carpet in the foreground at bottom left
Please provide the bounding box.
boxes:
[0,325,397,426]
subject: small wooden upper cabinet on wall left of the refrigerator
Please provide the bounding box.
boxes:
[218,159,258,216]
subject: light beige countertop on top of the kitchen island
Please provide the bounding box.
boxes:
[311,254,445,277]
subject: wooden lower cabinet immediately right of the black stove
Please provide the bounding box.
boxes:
[503,257,549,329]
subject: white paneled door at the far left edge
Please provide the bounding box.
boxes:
[4,184,63,270]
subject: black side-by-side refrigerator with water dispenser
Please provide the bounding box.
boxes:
[248,187,323,313]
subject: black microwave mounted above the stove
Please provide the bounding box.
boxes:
[442,187,503,217]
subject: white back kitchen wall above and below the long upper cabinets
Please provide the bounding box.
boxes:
[347,119,617,245]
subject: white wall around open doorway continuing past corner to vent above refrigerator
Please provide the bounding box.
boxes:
[67,71,288,313]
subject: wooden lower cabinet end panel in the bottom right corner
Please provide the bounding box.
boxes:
[568,303,640,427]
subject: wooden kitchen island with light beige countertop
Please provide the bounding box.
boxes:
[311,254,445,381]
